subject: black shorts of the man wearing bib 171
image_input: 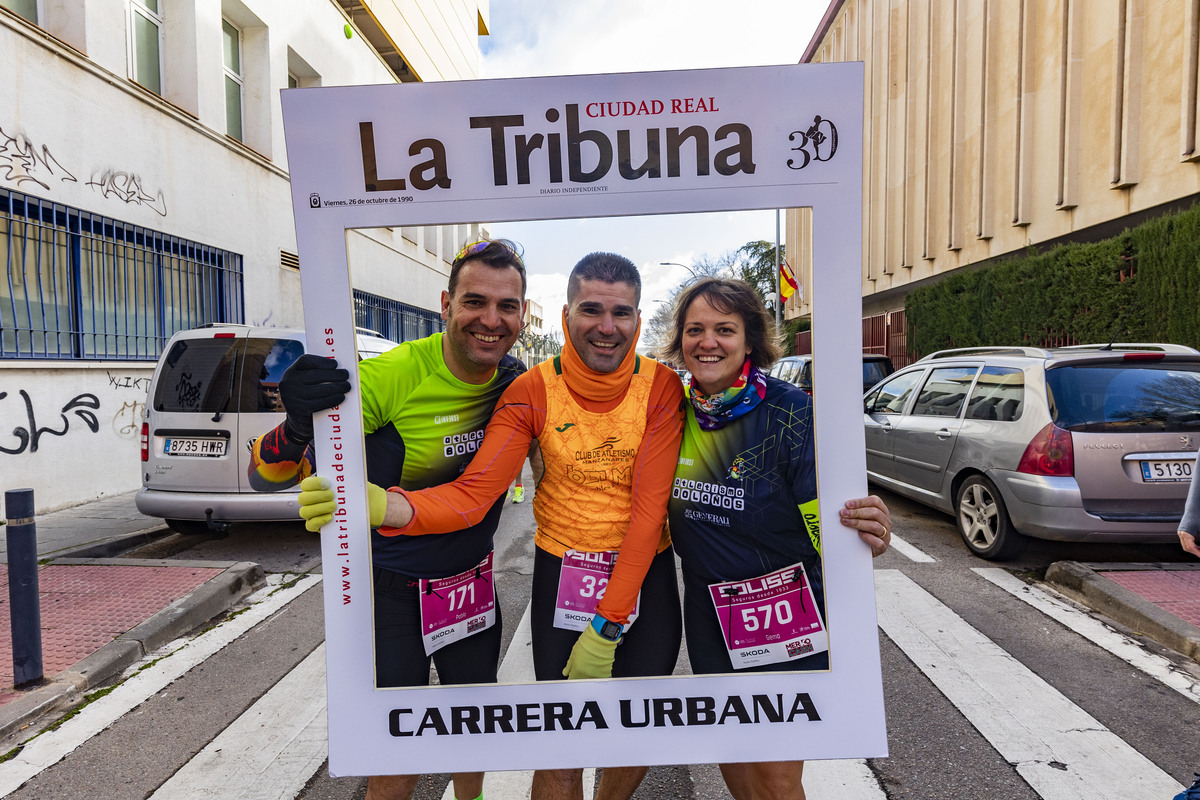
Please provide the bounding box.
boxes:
[374,569,500,687]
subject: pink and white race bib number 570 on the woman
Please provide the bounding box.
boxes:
[708,564,829,669]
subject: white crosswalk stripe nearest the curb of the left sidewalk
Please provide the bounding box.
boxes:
[0,575,320,798]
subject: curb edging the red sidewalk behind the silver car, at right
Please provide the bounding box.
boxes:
[1045,561,1200,661]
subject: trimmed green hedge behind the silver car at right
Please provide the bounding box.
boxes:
[905,206,1200,356]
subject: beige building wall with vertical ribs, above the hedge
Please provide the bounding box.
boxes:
[787,0,1200,315]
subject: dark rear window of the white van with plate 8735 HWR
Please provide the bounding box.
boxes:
[152,337,304,414]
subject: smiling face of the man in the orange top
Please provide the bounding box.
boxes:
[566,279,640,373]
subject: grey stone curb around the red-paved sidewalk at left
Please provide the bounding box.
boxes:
[0,559,266,739]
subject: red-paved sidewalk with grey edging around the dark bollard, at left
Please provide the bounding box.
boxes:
[0,492,264,738]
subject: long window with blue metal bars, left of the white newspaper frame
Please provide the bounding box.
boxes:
[0,190,245,361]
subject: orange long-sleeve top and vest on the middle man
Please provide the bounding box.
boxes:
[380,357,683,625]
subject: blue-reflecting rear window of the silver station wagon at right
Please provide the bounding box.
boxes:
[1046,361,1200,433]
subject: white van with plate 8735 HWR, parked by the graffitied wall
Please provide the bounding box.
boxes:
[137,324,397,534]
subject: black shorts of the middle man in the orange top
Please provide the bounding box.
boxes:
[529,547,683,680]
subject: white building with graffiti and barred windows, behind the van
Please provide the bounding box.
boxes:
[0,0,488,511]
